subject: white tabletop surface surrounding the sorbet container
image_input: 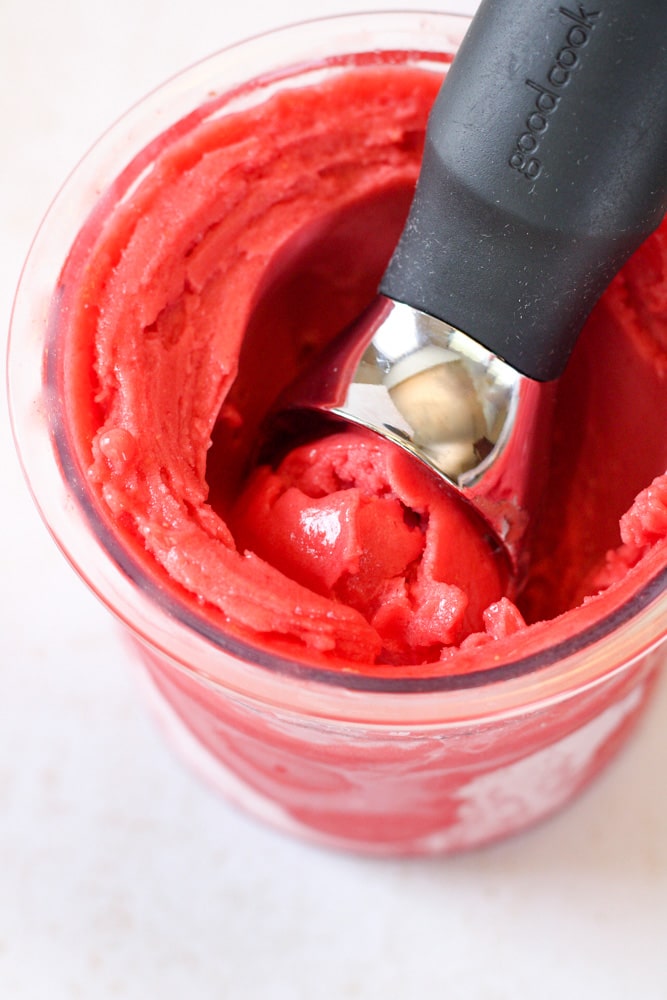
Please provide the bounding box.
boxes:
[0,0,667,1000]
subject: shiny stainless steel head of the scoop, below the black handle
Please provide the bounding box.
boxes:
[280,295,555,574]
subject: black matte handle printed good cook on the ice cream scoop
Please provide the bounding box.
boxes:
[380,0,667,381]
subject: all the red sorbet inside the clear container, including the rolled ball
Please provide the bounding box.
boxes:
[53,60,667,675]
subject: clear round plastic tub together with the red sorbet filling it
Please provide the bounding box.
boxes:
[10,12,667,854]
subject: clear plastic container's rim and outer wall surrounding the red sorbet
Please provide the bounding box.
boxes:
[10,12,667,855]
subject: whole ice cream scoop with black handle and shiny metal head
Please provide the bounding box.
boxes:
[272,0,667,574]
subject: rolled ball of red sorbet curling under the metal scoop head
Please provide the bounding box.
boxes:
[230,431,507,663]
